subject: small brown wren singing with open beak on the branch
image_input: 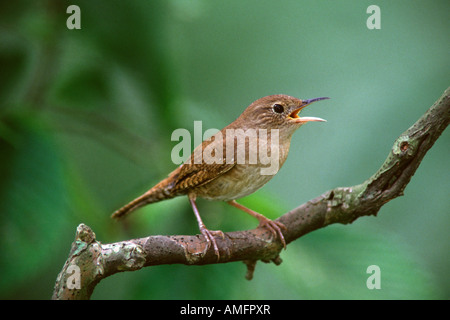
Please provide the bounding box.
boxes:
[112,95,328,259]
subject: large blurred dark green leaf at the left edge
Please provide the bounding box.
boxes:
[0,114,68,291]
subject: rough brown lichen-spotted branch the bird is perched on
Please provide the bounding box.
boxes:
[52,88,450,299]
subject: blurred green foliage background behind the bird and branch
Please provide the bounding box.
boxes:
[0,0,450,299]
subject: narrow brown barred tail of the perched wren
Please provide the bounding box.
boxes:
[111,180,176,219]
